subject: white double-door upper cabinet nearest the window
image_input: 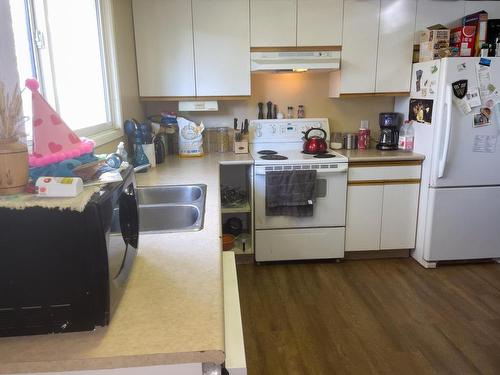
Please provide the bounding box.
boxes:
[133,0,250,98]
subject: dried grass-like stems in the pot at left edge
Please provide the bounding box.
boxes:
[0,82,25,142]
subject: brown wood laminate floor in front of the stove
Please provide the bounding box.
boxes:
[238,258,500,375]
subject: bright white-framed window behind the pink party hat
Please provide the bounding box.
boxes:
[10,0,121,136]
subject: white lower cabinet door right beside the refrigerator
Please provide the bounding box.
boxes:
[380,184,420,250]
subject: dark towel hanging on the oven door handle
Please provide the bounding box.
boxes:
[266,170,316,217]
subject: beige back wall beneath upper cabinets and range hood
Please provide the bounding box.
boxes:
[146,72,394,137]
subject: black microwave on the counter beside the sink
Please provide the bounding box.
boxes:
[0,168,139,336]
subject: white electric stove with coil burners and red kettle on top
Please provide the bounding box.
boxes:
[249,119,348,261]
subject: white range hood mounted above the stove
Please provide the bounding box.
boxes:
[250,51,340,72]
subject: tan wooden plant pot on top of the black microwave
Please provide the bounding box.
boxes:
[0,139,28,195]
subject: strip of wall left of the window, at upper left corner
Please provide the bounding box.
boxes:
[0,0,18,97]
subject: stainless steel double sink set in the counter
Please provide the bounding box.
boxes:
[137,184,207,233]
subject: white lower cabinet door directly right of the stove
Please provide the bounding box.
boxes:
[345,185,384,251]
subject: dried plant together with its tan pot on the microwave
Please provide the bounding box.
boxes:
[0,82,28,195]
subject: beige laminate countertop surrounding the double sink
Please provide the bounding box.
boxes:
[0,153,253,374]
